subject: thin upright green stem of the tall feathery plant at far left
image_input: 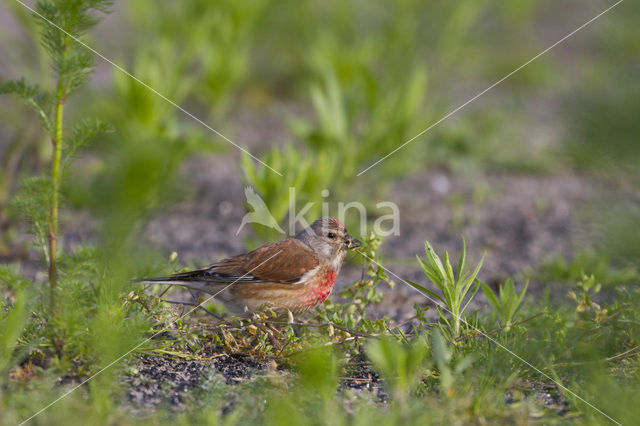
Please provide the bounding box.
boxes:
[49,36,69,314]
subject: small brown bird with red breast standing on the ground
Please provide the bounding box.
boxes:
[140,217,360,315]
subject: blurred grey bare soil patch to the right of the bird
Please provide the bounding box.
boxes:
[360,172,596,320]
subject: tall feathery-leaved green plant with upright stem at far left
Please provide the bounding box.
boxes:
[0,0,112,313]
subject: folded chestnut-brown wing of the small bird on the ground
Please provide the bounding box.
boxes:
[161,238,320,283]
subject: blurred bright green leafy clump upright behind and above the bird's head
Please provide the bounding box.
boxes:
[290,62,427,185]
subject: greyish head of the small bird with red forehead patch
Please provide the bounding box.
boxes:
[296,217,360,262]
